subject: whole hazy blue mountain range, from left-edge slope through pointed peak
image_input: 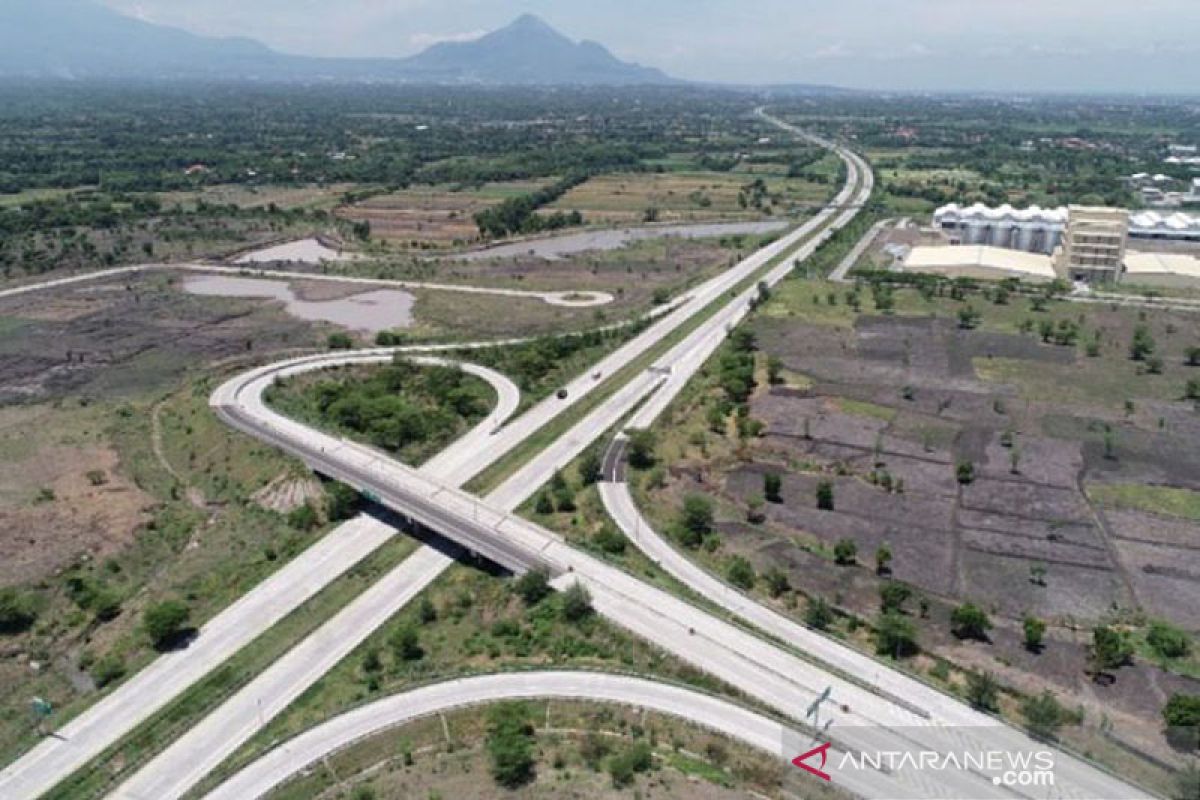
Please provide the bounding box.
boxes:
[0,0,673,85]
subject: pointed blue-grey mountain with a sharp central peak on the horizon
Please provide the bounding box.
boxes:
[404,14,672,85]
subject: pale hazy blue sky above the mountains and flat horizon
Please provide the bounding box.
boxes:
[102,0,1200,92]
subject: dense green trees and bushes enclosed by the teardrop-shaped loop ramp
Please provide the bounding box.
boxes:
[266,356,496,464]
